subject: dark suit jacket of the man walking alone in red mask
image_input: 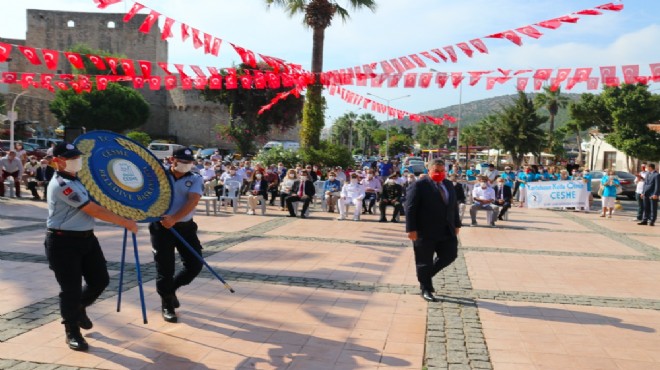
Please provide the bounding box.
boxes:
[405,177,461,240]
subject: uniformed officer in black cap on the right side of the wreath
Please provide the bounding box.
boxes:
[149,148,204,322]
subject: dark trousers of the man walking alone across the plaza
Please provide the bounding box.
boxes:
[413,236,458,290]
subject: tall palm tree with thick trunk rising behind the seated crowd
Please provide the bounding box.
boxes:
[266,0,376,148]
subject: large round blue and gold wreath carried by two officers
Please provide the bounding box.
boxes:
[75,131,172,222]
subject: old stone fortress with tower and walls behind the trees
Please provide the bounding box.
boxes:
[0,9,299,149]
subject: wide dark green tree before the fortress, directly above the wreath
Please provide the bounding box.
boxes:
[50,83,149,132]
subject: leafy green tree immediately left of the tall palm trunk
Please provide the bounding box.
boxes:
[201,63,303,155]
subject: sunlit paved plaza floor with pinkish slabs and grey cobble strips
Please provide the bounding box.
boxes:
[0,198,660,370]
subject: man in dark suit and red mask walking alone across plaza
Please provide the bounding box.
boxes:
[406,159,461,302]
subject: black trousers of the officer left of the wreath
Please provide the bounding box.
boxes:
[44,233,110,324]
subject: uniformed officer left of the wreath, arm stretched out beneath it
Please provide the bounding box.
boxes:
[45,142,137,351]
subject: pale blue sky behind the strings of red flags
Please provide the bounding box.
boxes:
[0,0,660,126]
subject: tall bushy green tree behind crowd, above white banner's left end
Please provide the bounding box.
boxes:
[486,91,548,167]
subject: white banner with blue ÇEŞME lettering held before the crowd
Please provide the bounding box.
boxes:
[526,180,589,208]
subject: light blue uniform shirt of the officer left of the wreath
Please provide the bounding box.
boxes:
[46,172,94,231]
